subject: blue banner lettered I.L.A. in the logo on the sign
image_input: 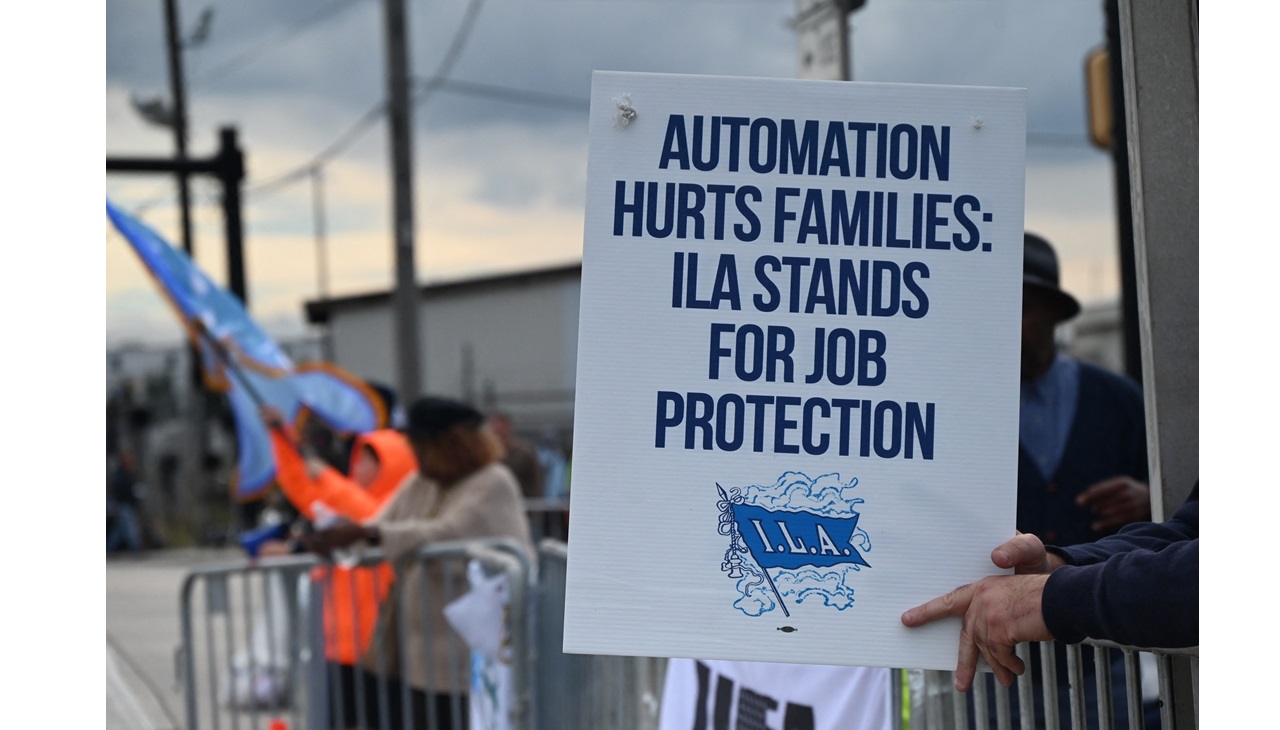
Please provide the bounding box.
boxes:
[732,505,870,570]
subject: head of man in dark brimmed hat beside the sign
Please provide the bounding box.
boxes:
[1021,233,1080,380]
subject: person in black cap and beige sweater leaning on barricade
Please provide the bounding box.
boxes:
[306,396,534,727]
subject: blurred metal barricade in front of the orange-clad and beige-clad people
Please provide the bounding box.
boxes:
[178,539,535,730]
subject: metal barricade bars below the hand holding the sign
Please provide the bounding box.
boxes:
[896,640,1199,730]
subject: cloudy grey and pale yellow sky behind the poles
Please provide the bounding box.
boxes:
[104,0,1117,343]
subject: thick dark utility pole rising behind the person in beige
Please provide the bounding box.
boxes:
[383,0,421,403]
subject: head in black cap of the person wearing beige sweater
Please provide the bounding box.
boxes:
[404,396,503,485]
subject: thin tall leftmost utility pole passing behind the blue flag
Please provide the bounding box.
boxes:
[164,0,209,527]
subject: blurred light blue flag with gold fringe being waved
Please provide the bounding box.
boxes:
[106,201,387,498]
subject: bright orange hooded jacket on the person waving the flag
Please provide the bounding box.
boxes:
[271,429,417,665]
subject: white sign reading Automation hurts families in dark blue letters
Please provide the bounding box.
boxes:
[564,72,1025,669]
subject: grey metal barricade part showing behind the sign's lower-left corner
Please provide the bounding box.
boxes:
[534,539,667,730]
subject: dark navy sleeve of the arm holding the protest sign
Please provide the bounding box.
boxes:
[1041,485,1199,648]
